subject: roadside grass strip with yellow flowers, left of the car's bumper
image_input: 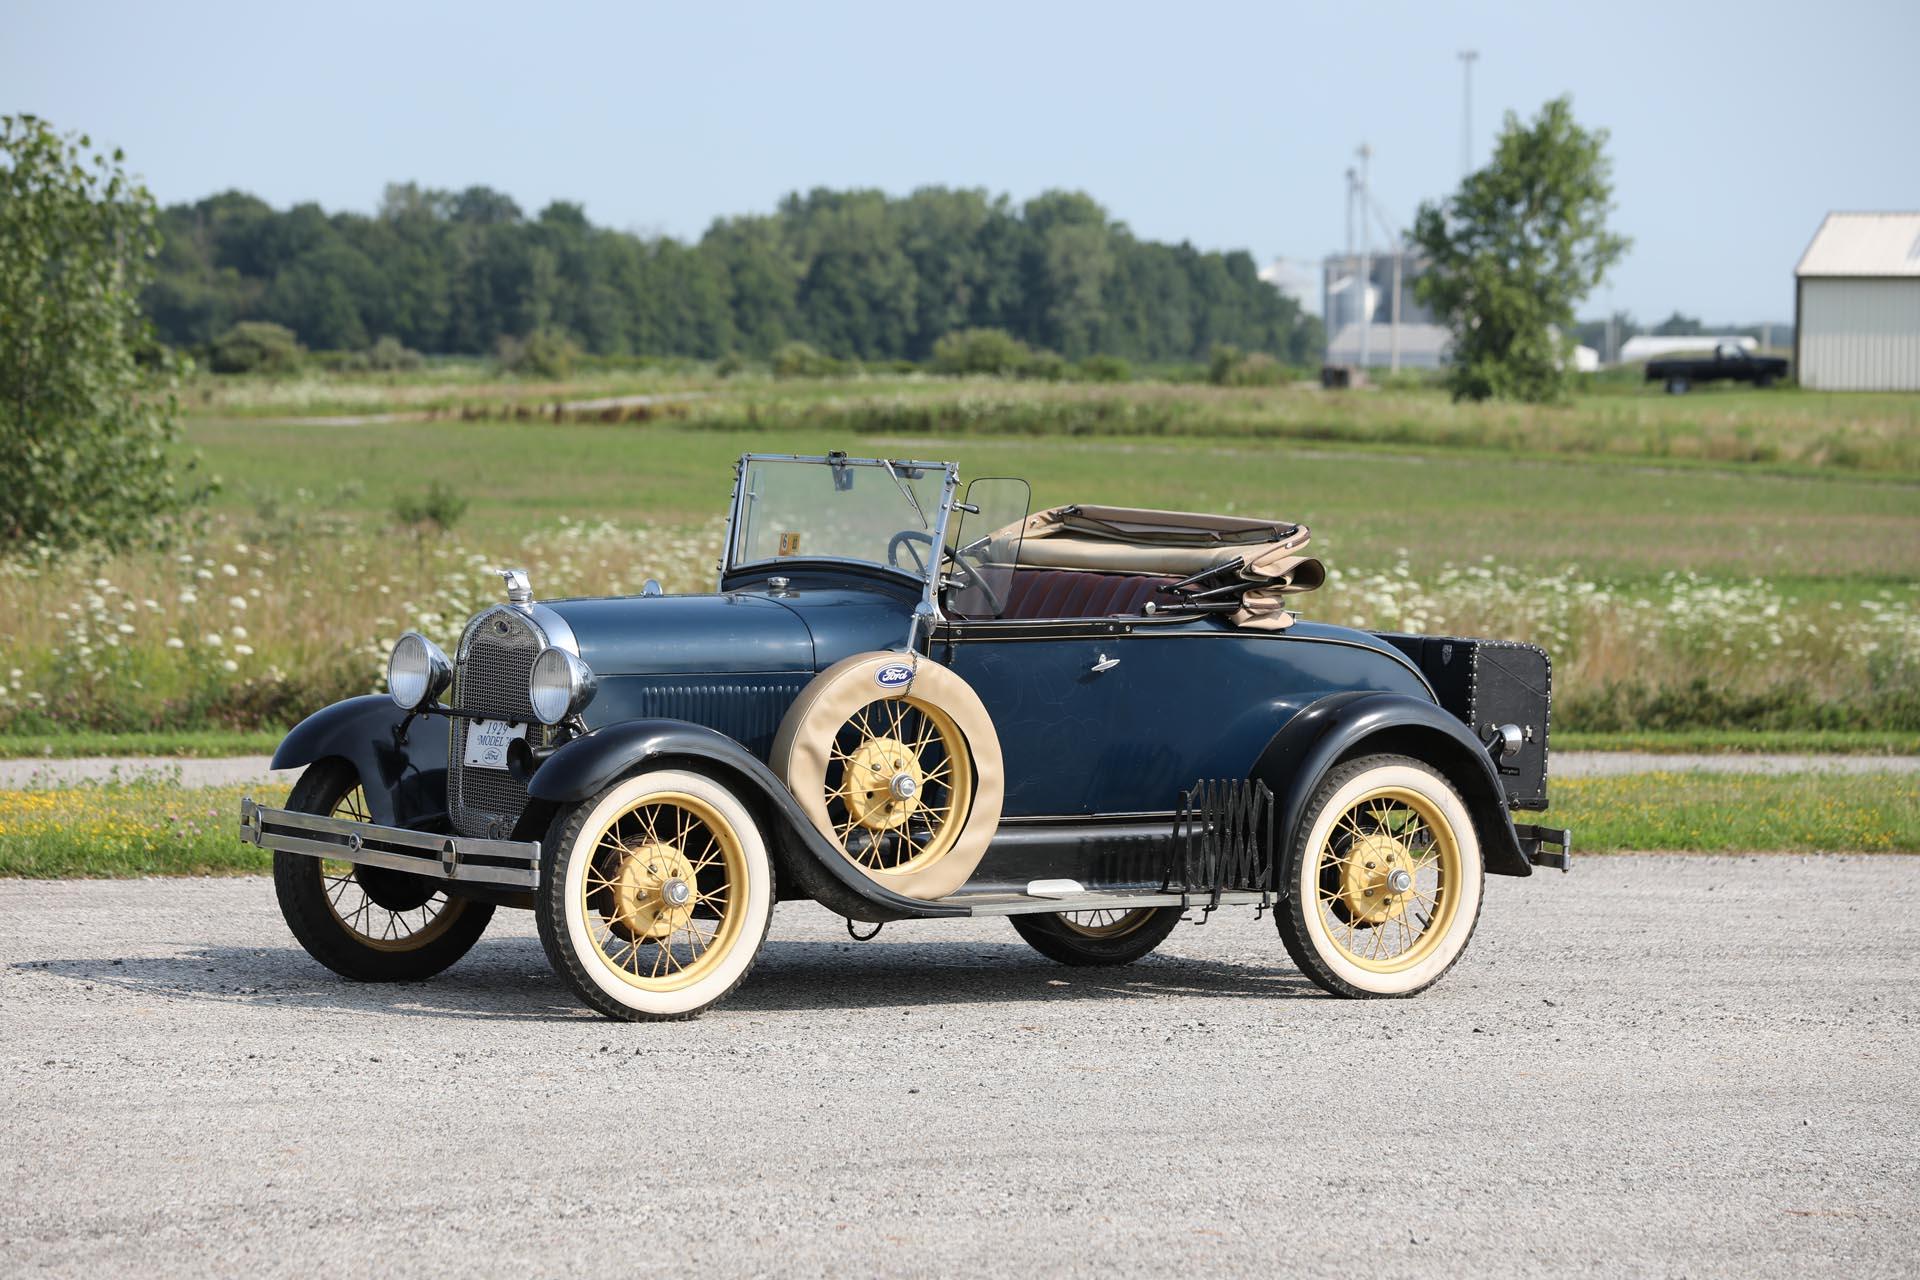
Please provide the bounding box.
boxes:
[0,781,286,879]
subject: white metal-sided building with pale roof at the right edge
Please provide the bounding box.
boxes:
[1793,213,1920,391]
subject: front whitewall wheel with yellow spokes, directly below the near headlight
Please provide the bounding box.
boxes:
[536,770,774,1021]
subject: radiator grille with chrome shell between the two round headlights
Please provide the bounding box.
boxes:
[447,608,547,837]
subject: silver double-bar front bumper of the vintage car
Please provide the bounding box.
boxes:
[240,796,540,889]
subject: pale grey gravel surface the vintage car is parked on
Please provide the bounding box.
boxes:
[0,856,1920,1280]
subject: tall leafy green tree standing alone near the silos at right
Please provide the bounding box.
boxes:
[1413,98,1628,401]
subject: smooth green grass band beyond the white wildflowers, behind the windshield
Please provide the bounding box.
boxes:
[188,420,1920,579]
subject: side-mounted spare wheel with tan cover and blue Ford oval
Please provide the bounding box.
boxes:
[770,652,1004,900]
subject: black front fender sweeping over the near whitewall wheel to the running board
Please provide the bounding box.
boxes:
[526,720,966,921]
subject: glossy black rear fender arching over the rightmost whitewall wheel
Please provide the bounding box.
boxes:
[1254,691,1534,883]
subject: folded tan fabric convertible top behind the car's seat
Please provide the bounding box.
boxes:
[987,505,1327,631]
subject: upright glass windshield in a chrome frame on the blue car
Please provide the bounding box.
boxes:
[728,455,948,580]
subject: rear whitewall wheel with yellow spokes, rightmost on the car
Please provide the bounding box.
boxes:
[1275,756,1486,998]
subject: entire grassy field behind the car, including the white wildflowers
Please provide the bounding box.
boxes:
[0,372,1920,741]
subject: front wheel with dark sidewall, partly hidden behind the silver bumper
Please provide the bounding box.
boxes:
[273,760,493,983]
